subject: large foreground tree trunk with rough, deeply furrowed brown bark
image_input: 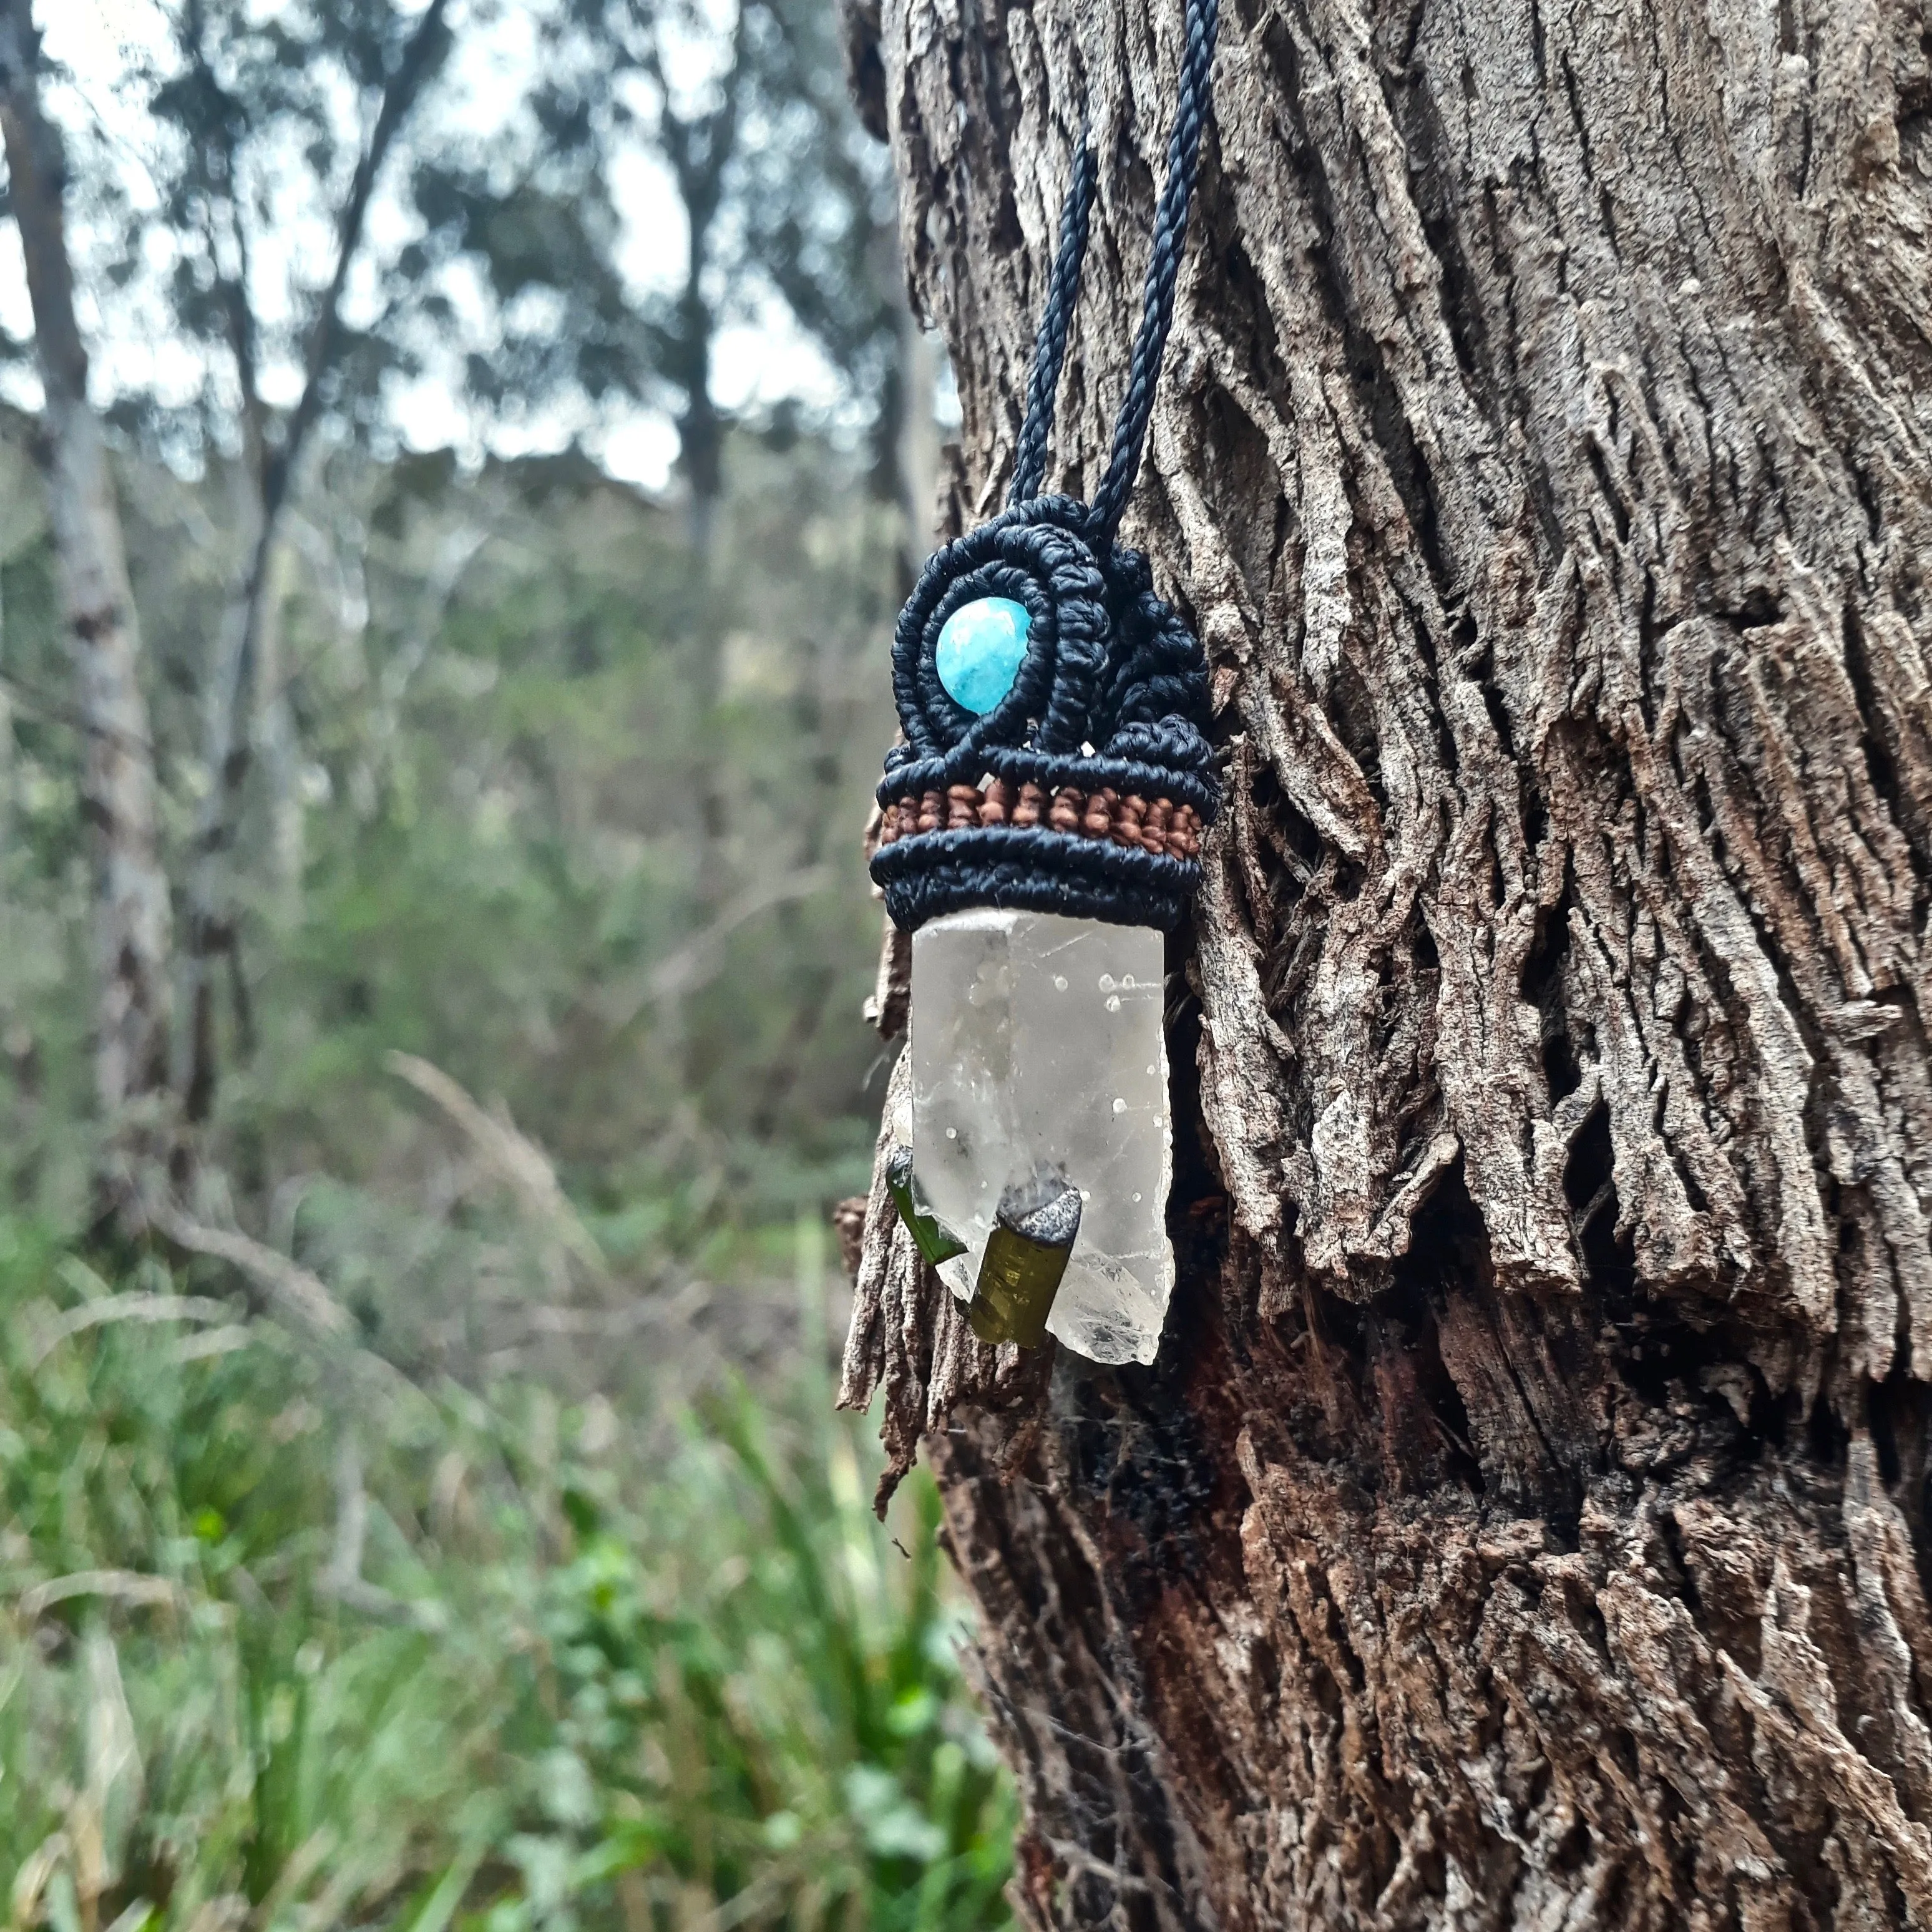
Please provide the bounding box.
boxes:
[846,0,1932,1932]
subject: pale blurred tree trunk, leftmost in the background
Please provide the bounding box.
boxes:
[0,0,170,1159]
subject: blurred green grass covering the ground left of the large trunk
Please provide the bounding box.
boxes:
[0,1223,1012,1932]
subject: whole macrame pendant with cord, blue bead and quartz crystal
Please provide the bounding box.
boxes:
[871,0,1219,1362]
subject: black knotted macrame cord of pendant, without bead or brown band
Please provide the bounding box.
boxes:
[871,0,1219,931]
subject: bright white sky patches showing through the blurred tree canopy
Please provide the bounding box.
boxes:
[0,0,841,489]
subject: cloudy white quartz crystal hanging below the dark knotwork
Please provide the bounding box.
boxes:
[910,908,1174,1362]
